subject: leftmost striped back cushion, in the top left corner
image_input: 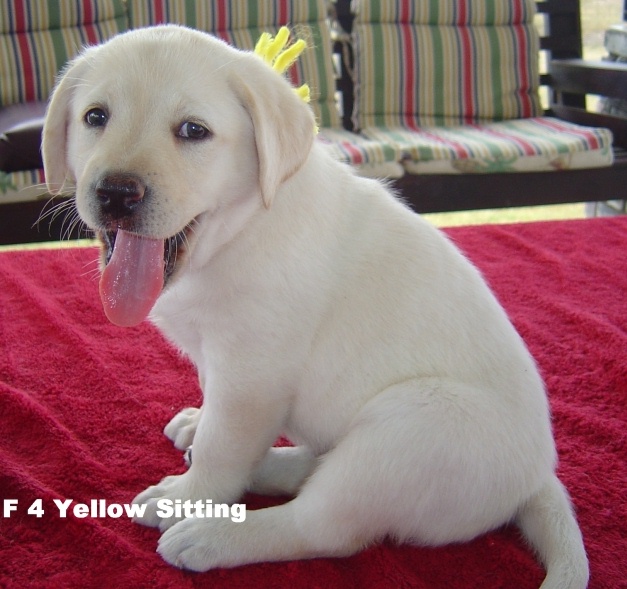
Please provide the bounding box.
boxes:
[0,0,126,105]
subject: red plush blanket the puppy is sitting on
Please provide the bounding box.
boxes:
[0,218,627,589]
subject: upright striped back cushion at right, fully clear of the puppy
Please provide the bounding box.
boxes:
[353,0,541,129]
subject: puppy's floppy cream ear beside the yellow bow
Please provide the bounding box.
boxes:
[232,56,315,208]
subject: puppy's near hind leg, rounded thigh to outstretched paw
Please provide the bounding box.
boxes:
[158,379,544,571]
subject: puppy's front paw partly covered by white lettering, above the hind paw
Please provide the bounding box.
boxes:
[133,471,200,532]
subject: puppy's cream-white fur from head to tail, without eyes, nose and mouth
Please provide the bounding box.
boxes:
[44,27,588,589]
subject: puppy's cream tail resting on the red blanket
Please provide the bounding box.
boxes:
[516,476,589,589]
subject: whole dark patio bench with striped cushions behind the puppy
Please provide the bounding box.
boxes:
[0,0,627,244]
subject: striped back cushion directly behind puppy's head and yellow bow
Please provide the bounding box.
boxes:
[128,0,341,127]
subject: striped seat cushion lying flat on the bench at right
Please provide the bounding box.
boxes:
[362,117,613,173]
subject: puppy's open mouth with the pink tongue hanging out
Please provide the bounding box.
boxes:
[99,222,193,327]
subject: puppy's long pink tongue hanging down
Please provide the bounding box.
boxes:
[100,229,164,327]
